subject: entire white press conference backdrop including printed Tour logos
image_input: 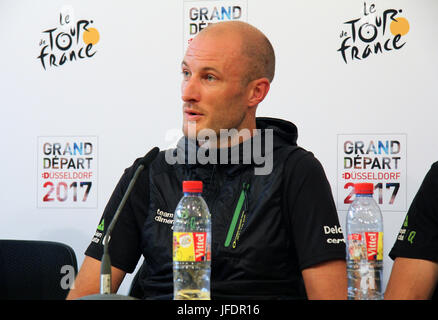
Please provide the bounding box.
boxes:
[0,0,438,294]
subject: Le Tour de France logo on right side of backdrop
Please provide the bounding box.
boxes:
[338,2,409,63]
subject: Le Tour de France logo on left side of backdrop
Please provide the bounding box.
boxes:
[37,6,100,70]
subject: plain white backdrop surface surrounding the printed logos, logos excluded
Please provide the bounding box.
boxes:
[0,0,438,293]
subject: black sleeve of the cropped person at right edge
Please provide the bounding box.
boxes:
[389,162,438,262]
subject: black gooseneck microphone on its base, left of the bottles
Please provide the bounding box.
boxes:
[82,147,160,300]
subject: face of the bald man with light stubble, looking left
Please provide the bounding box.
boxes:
[181,34,247,136]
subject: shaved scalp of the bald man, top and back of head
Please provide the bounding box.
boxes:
[197,21,275,84]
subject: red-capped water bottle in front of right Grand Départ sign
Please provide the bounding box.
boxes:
[346,183,383,300]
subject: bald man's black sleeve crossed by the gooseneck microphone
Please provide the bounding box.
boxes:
[85,159,148,273]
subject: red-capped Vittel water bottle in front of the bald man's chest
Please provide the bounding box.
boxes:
[173,181,211,300]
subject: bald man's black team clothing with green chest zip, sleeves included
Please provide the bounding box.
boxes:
[86,118,345,299]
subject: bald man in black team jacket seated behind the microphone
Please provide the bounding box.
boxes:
[69,22,347,299]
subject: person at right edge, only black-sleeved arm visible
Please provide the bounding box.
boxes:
[385,162,438,300]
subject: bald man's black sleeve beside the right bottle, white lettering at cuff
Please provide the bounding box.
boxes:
[285,150,345,270]
